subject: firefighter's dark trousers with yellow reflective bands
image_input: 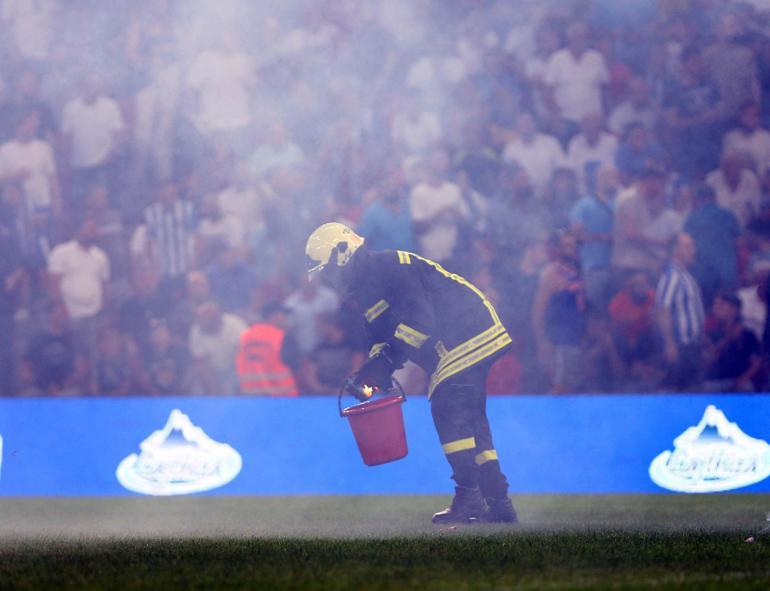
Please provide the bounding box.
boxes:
[431,363,508,499]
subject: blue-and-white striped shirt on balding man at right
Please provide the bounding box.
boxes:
[655,263,705,345]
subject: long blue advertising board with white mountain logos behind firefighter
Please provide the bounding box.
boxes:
[0,394,770,496]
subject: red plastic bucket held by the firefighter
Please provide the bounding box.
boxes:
[341,394,408,466]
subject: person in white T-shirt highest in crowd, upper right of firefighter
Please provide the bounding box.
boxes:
[544,23,609,123]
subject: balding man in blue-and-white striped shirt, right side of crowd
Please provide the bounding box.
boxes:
[655,232,705,390]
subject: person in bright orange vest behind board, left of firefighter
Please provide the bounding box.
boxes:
[236,303,299,396]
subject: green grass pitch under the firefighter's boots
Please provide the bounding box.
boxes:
[0,495,770,591]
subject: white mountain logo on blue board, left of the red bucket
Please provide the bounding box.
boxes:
[116,410,242,496]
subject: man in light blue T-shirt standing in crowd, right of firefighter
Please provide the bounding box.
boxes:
[570,166,620,310]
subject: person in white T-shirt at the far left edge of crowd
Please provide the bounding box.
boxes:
[0,111,61,217]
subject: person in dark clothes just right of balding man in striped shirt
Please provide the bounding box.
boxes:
[704,291,762,392]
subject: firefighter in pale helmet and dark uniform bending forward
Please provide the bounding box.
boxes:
[305,222,516,523]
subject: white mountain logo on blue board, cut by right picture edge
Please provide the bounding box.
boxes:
[650,404,770,493]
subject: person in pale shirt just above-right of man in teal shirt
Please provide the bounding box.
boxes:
[706,152,762,228]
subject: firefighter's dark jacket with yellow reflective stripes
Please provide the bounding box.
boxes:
[345,246,511,395]
